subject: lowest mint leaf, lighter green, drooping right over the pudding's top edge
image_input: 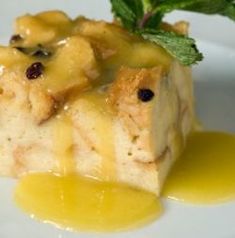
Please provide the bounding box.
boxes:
[139,29,203,66]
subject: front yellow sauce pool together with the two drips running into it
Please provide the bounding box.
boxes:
[12,86,162,231]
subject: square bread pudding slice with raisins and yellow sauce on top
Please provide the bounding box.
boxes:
[0,11,194,195]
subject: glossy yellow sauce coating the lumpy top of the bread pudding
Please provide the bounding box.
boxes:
[0,11,172,97]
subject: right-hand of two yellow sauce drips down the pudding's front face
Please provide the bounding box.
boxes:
[78,88,116,181]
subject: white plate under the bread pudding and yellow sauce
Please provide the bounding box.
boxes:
[0,0,235,238]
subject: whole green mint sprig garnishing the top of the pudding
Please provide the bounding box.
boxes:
[110,0,235,66]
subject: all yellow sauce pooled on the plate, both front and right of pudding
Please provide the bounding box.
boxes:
[15,132,235,231]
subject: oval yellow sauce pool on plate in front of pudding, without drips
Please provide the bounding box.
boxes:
[15,174,162,231]
